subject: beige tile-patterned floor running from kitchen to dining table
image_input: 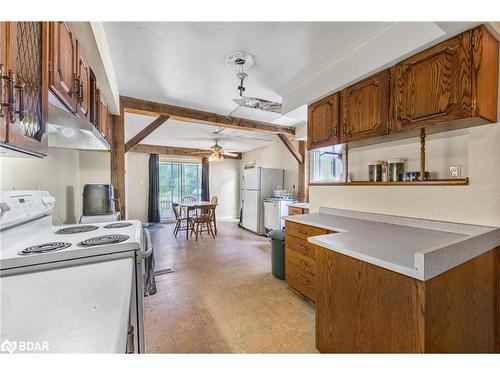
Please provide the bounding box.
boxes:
[145,223,317,353]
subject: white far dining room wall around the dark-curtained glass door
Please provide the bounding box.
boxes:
[125,152,240,222]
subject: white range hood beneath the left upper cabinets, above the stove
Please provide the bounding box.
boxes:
[47,94,110,151]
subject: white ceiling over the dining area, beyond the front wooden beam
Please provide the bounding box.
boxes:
[125,113,278,152]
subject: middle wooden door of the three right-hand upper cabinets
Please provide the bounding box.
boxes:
[340,70,390,143]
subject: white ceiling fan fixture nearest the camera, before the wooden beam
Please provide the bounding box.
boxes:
[226,52,282,114]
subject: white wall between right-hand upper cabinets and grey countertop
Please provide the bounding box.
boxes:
[309,123,500,226]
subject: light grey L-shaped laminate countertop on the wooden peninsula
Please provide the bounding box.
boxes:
[285,208,500,280]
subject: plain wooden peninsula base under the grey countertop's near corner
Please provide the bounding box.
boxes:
[316,247,500,353]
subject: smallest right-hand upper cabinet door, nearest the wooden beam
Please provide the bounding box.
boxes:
[307,93,339,150]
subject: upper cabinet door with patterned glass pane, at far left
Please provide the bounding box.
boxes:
[1,22,48,156]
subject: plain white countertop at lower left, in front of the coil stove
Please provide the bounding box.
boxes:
[0,258,134,353]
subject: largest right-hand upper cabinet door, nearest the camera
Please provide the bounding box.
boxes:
[391,31,473,131]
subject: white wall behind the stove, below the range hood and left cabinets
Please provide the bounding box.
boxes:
[0,148,110,225]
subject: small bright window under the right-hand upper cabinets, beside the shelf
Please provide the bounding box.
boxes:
[310,146,344,182]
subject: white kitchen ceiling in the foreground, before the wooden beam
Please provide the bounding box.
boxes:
[104,22,392,114]
